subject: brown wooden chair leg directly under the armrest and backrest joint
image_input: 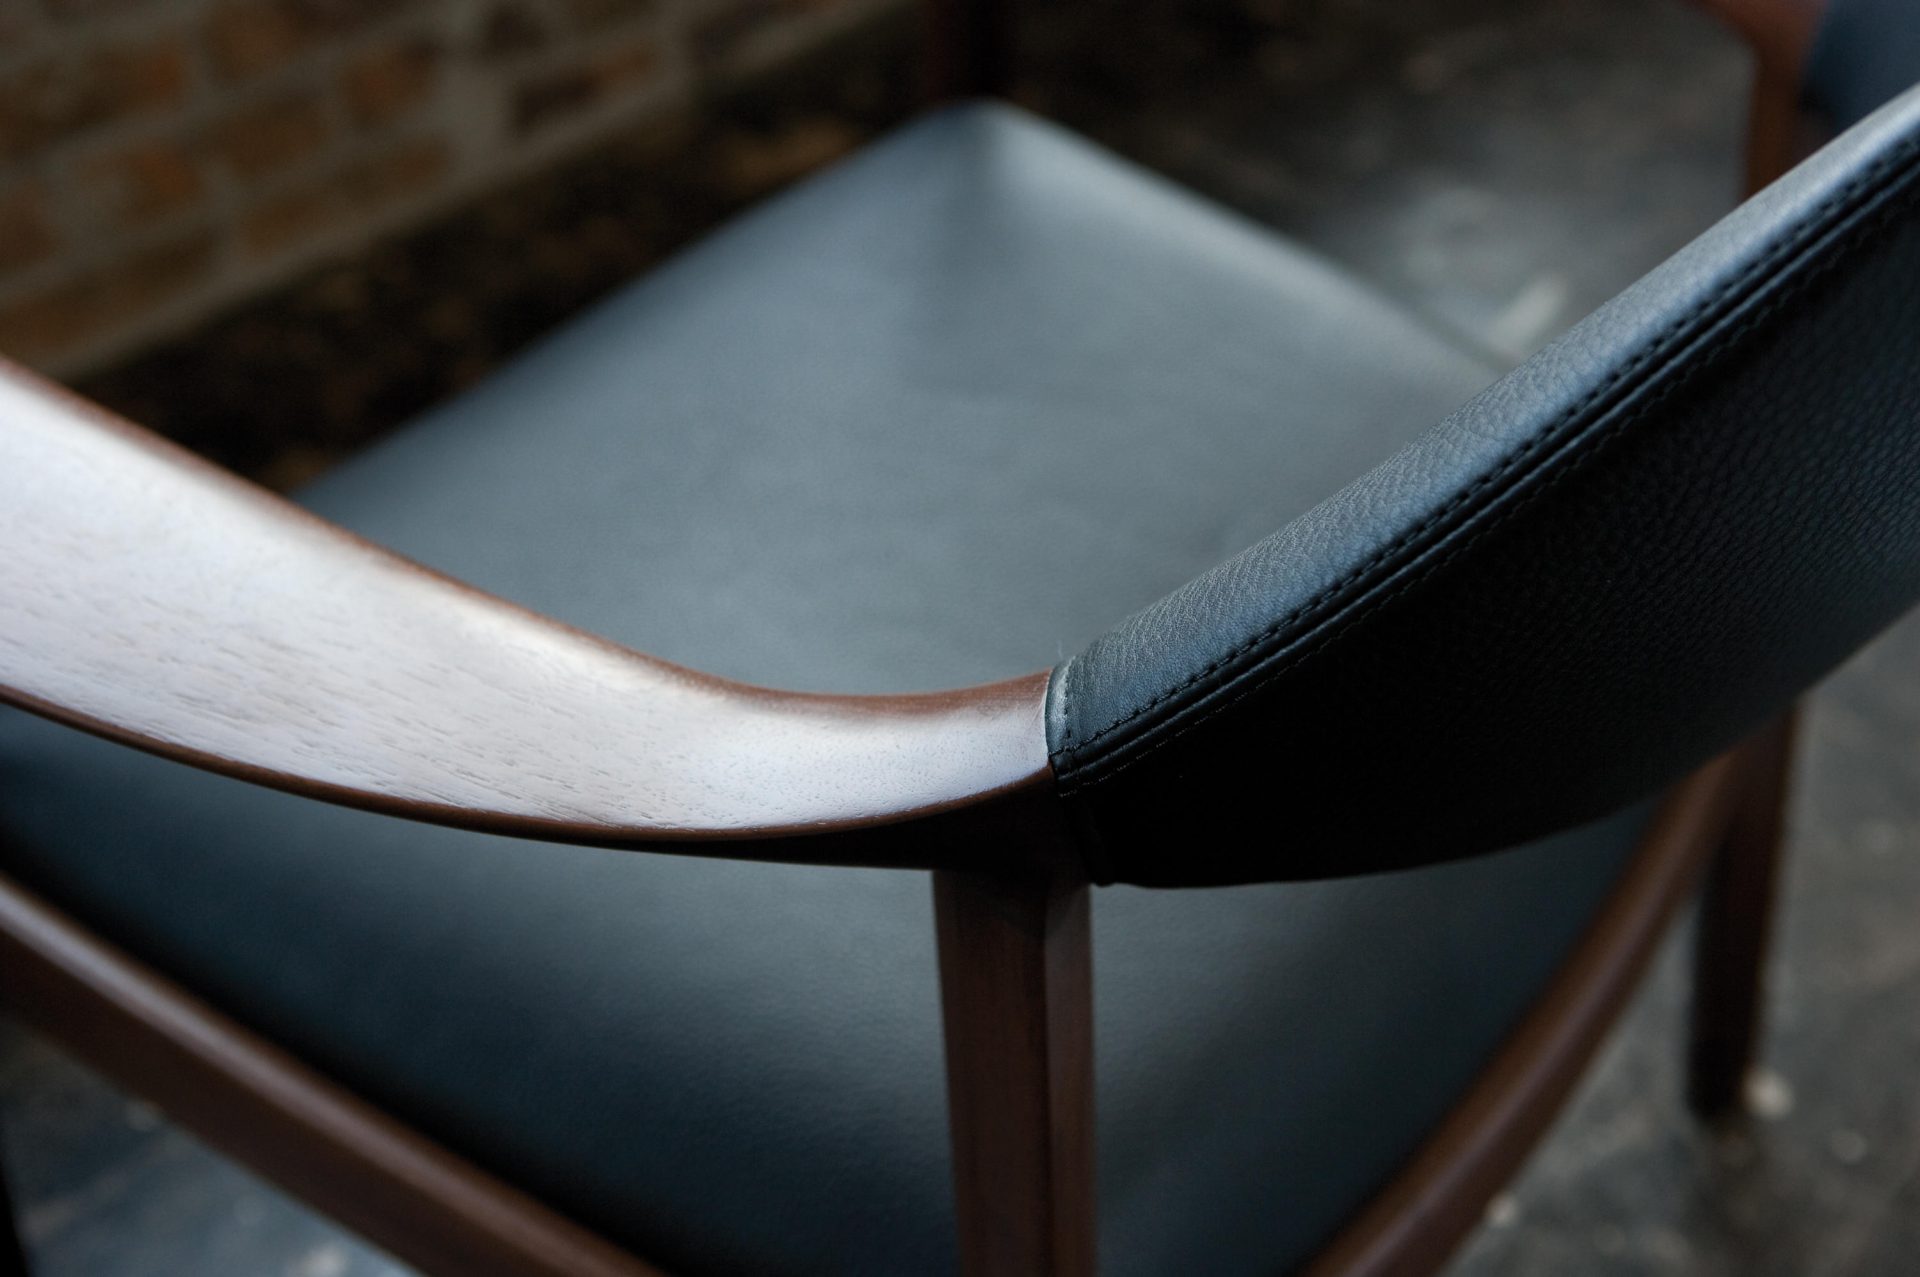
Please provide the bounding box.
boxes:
[933,872,1094,1277]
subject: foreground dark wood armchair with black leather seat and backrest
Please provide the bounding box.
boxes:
[0,0,1920,1277]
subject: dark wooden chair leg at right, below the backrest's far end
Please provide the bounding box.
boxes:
[1688,712,1795,1120]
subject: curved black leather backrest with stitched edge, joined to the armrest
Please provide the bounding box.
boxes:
[1048,90,1920,885]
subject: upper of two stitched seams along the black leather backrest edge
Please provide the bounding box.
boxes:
[1052,129,1920,770]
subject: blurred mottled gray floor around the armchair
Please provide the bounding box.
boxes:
[11,0,1920,1277]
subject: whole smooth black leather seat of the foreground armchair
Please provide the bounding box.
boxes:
[0,108,1642,1273]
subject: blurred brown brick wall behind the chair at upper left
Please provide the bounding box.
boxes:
[0,0,900,376]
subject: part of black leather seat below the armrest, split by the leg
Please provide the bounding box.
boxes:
[0,722,1640,1277]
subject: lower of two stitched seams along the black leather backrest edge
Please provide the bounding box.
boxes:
[1068,148,1920,793]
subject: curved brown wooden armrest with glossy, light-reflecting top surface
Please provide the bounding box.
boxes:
[0,363,1050,864]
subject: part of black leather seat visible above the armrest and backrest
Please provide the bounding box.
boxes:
[232,108,1496,691]
